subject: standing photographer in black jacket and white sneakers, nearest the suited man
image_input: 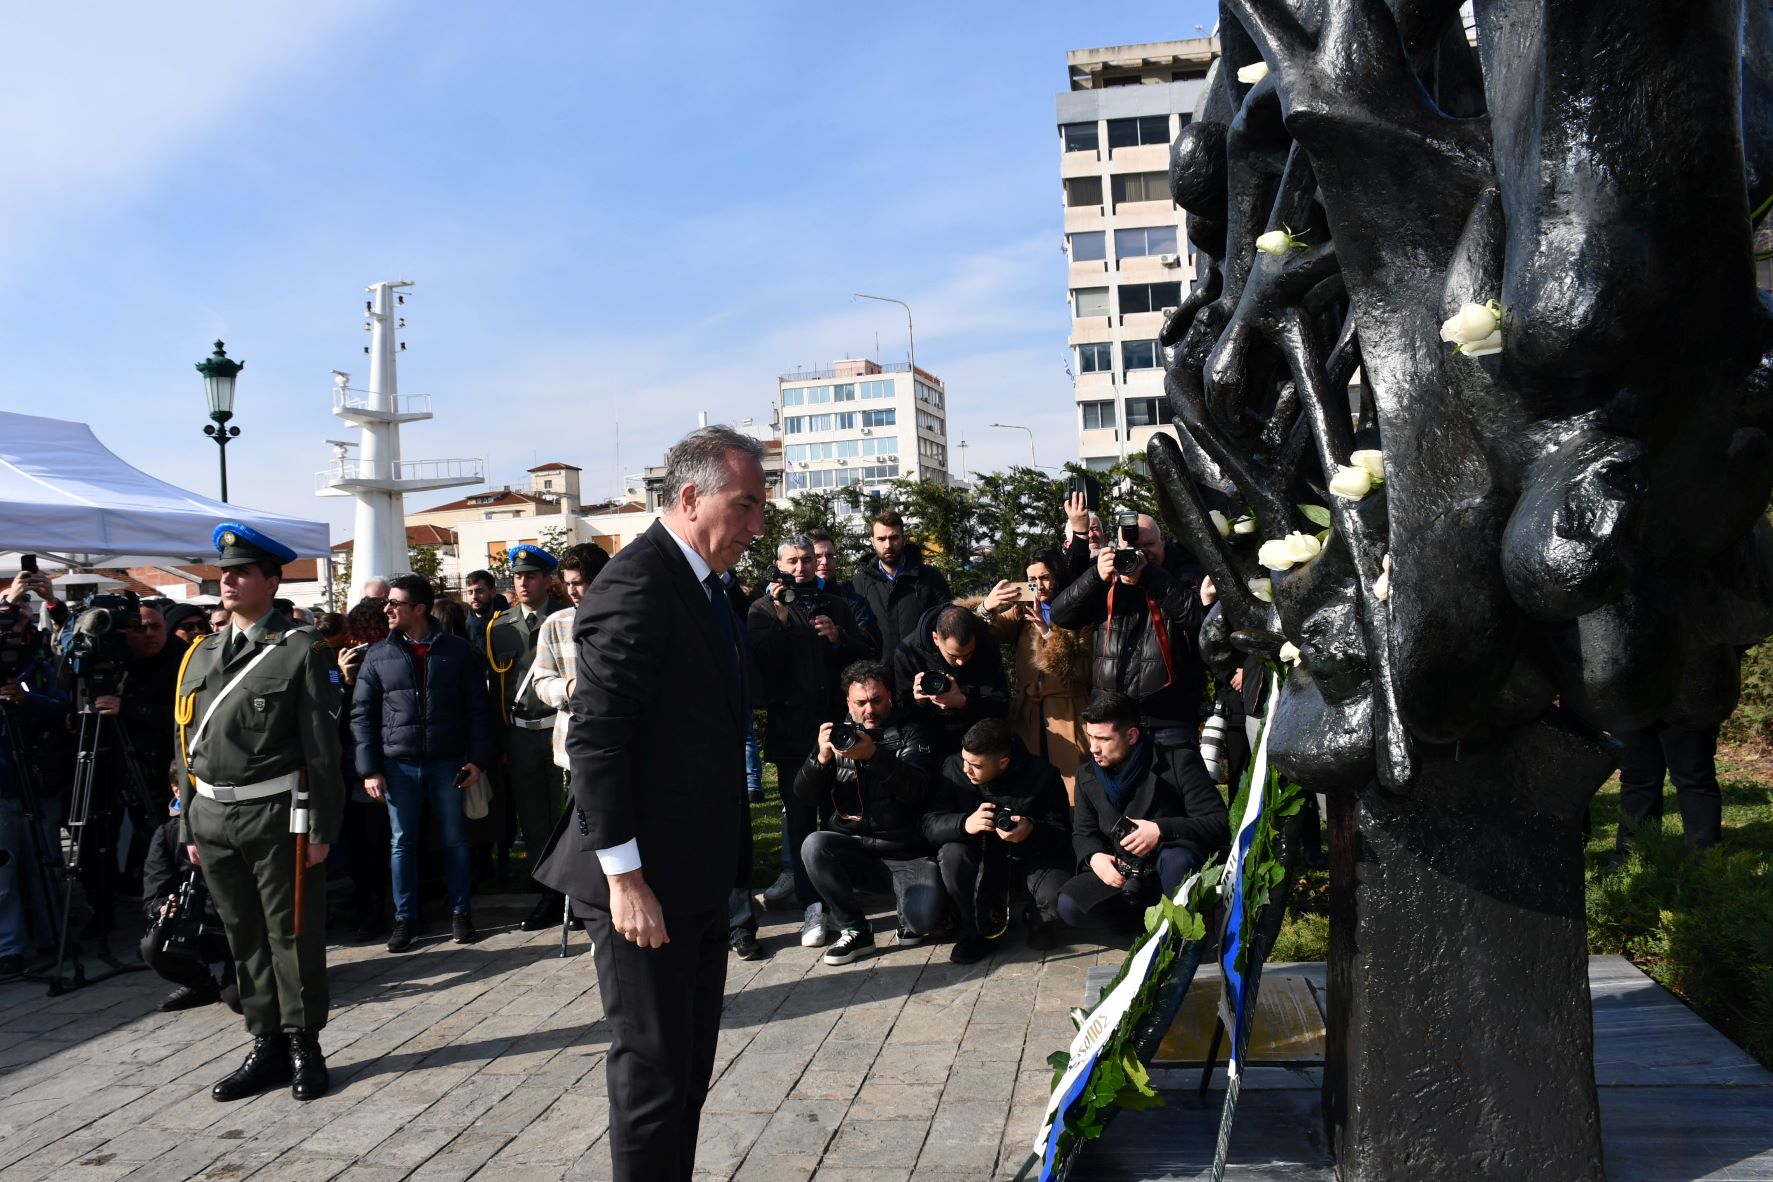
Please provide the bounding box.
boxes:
[746,535,872,948]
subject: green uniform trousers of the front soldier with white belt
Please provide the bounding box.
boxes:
[190,794,332,1037]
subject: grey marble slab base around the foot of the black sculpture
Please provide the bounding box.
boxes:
[1071,957,1773,1182]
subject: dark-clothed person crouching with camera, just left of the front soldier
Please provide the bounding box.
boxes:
[142,796,241,1014]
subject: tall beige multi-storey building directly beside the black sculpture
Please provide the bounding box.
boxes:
[1057,37,1218,470]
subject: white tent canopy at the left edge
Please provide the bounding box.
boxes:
[0,411,328,565]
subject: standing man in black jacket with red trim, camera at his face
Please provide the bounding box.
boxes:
[1053,514,1206,748]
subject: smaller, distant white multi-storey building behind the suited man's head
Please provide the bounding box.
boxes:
[777,360,949,496]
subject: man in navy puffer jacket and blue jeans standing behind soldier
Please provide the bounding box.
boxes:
[351,574,493,952]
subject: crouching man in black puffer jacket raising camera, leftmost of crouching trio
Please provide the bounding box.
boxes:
[794,661,947,964]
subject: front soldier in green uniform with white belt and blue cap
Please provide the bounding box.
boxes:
[176,521,344,1100]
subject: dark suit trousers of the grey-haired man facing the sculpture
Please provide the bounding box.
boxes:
[588,904,727,1182]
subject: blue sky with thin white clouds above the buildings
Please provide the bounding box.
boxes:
[0,0,1213,537]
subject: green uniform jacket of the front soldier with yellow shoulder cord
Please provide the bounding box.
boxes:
[172,611,346,845]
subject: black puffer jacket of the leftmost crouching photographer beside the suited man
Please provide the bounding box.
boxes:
[794,723,929,858]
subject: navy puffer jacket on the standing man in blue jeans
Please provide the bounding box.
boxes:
[351,624,493,776]
